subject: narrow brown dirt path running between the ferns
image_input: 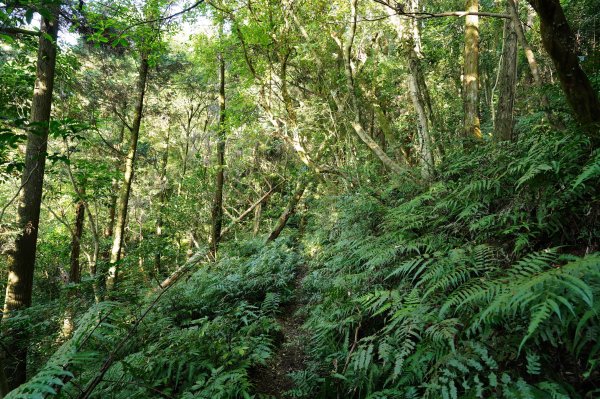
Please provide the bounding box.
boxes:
[252,265,308,398]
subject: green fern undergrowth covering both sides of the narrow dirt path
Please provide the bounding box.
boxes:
[9,132,600,399]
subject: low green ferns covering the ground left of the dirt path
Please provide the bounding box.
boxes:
[7,239,300,399]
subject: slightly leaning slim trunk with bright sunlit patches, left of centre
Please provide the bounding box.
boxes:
[106,54,148,292]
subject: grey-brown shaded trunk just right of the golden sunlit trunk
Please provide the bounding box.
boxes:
[494,0,517,141]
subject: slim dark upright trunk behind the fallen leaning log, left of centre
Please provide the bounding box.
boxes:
[210,54,225,257]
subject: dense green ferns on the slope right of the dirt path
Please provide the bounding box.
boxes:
[297,133,600,399]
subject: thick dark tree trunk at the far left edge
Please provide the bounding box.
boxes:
[3,6,58,389]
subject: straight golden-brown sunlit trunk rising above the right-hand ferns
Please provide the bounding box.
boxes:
[463,0,483,139]
